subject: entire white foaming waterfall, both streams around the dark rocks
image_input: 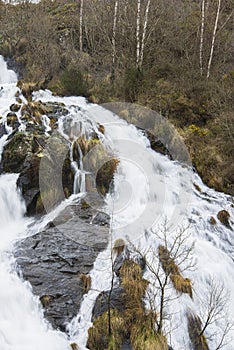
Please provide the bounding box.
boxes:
[0,56,234,350]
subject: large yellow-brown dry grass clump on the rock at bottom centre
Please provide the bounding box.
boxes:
[87,258,168,350]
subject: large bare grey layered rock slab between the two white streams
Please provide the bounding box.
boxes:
[15,204,109,331]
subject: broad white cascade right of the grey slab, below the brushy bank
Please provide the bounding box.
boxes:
[35,91,234,350]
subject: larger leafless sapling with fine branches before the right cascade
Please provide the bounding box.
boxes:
[131,223,194,333]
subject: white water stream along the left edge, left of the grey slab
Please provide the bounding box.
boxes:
[0,56,69,350]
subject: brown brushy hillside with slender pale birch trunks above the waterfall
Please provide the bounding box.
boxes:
[0,0,234,194]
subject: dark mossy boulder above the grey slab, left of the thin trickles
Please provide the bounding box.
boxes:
[1,123,74,215]
